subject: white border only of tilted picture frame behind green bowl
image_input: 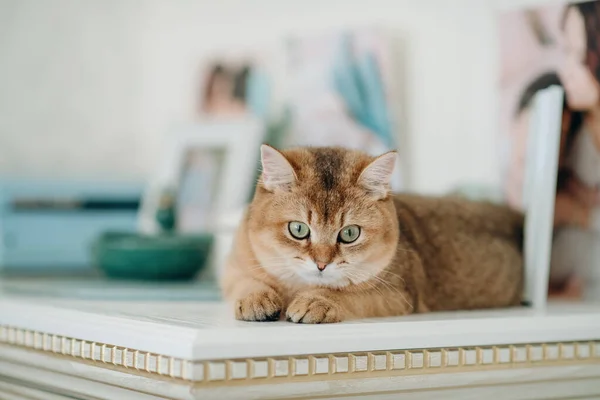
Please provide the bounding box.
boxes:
[138,115,265,276]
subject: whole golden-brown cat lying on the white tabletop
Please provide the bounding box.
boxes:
[221,145,523,323]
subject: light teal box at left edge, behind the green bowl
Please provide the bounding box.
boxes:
[0,181,143,273]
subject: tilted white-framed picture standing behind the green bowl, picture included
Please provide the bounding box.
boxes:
[139,116,264,276]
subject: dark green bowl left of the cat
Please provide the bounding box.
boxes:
[93,232,213,281]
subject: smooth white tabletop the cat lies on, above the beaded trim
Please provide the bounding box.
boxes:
[0,286,600,360]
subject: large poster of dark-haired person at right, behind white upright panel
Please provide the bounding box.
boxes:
[499,1,600,299]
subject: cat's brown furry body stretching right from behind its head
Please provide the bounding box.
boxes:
[393,194,523,310]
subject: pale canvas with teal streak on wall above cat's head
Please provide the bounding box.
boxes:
[285,28,403,190]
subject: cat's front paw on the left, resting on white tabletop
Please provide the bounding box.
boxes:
[235,289,283,321]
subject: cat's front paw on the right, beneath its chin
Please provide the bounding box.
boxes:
[287,293,342,324]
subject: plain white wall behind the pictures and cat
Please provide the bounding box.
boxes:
[0,0,552,192]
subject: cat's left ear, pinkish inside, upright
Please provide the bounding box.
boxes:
[260,144,296,192]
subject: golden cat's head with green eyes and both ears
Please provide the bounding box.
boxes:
[248,145,398,288]
